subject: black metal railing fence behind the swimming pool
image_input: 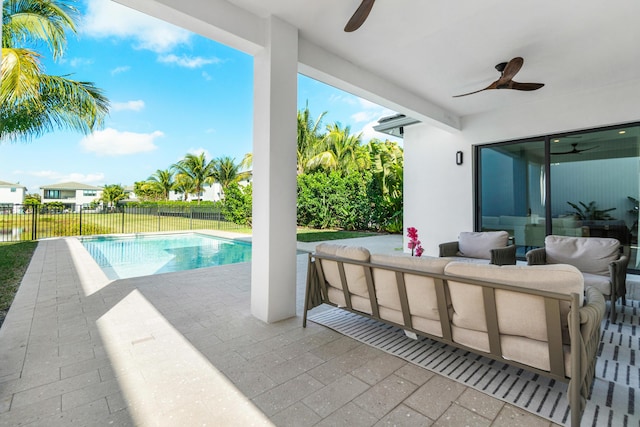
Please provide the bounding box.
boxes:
[0,205,243,242]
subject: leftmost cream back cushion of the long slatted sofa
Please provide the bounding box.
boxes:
[316,243,371,298]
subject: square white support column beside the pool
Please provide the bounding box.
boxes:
[251,17,298,323]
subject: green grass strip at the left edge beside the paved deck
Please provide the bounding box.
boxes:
[0,242,38,324]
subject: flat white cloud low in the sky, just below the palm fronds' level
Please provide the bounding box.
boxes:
[80,128,164,156]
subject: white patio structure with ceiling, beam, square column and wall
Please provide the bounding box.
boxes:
[111,0,640,322]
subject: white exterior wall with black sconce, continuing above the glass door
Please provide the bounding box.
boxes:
[404,81,640,256]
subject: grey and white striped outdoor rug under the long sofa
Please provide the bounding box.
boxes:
[309,300,640,427]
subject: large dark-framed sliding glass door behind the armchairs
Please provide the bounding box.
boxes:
[476,124,640,269]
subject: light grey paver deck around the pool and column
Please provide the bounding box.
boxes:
[0,233,553,427]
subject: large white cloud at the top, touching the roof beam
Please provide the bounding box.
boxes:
[82,0,190,53]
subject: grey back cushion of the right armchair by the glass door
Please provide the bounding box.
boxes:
[544,235,620,276]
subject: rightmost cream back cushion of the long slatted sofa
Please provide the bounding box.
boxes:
[445,262,584,341]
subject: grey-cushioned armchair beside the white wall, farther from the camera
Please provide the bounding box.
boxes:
[440,231,516,265]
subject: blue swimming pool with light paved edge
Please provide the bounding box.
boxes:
[80,233,251,280]
